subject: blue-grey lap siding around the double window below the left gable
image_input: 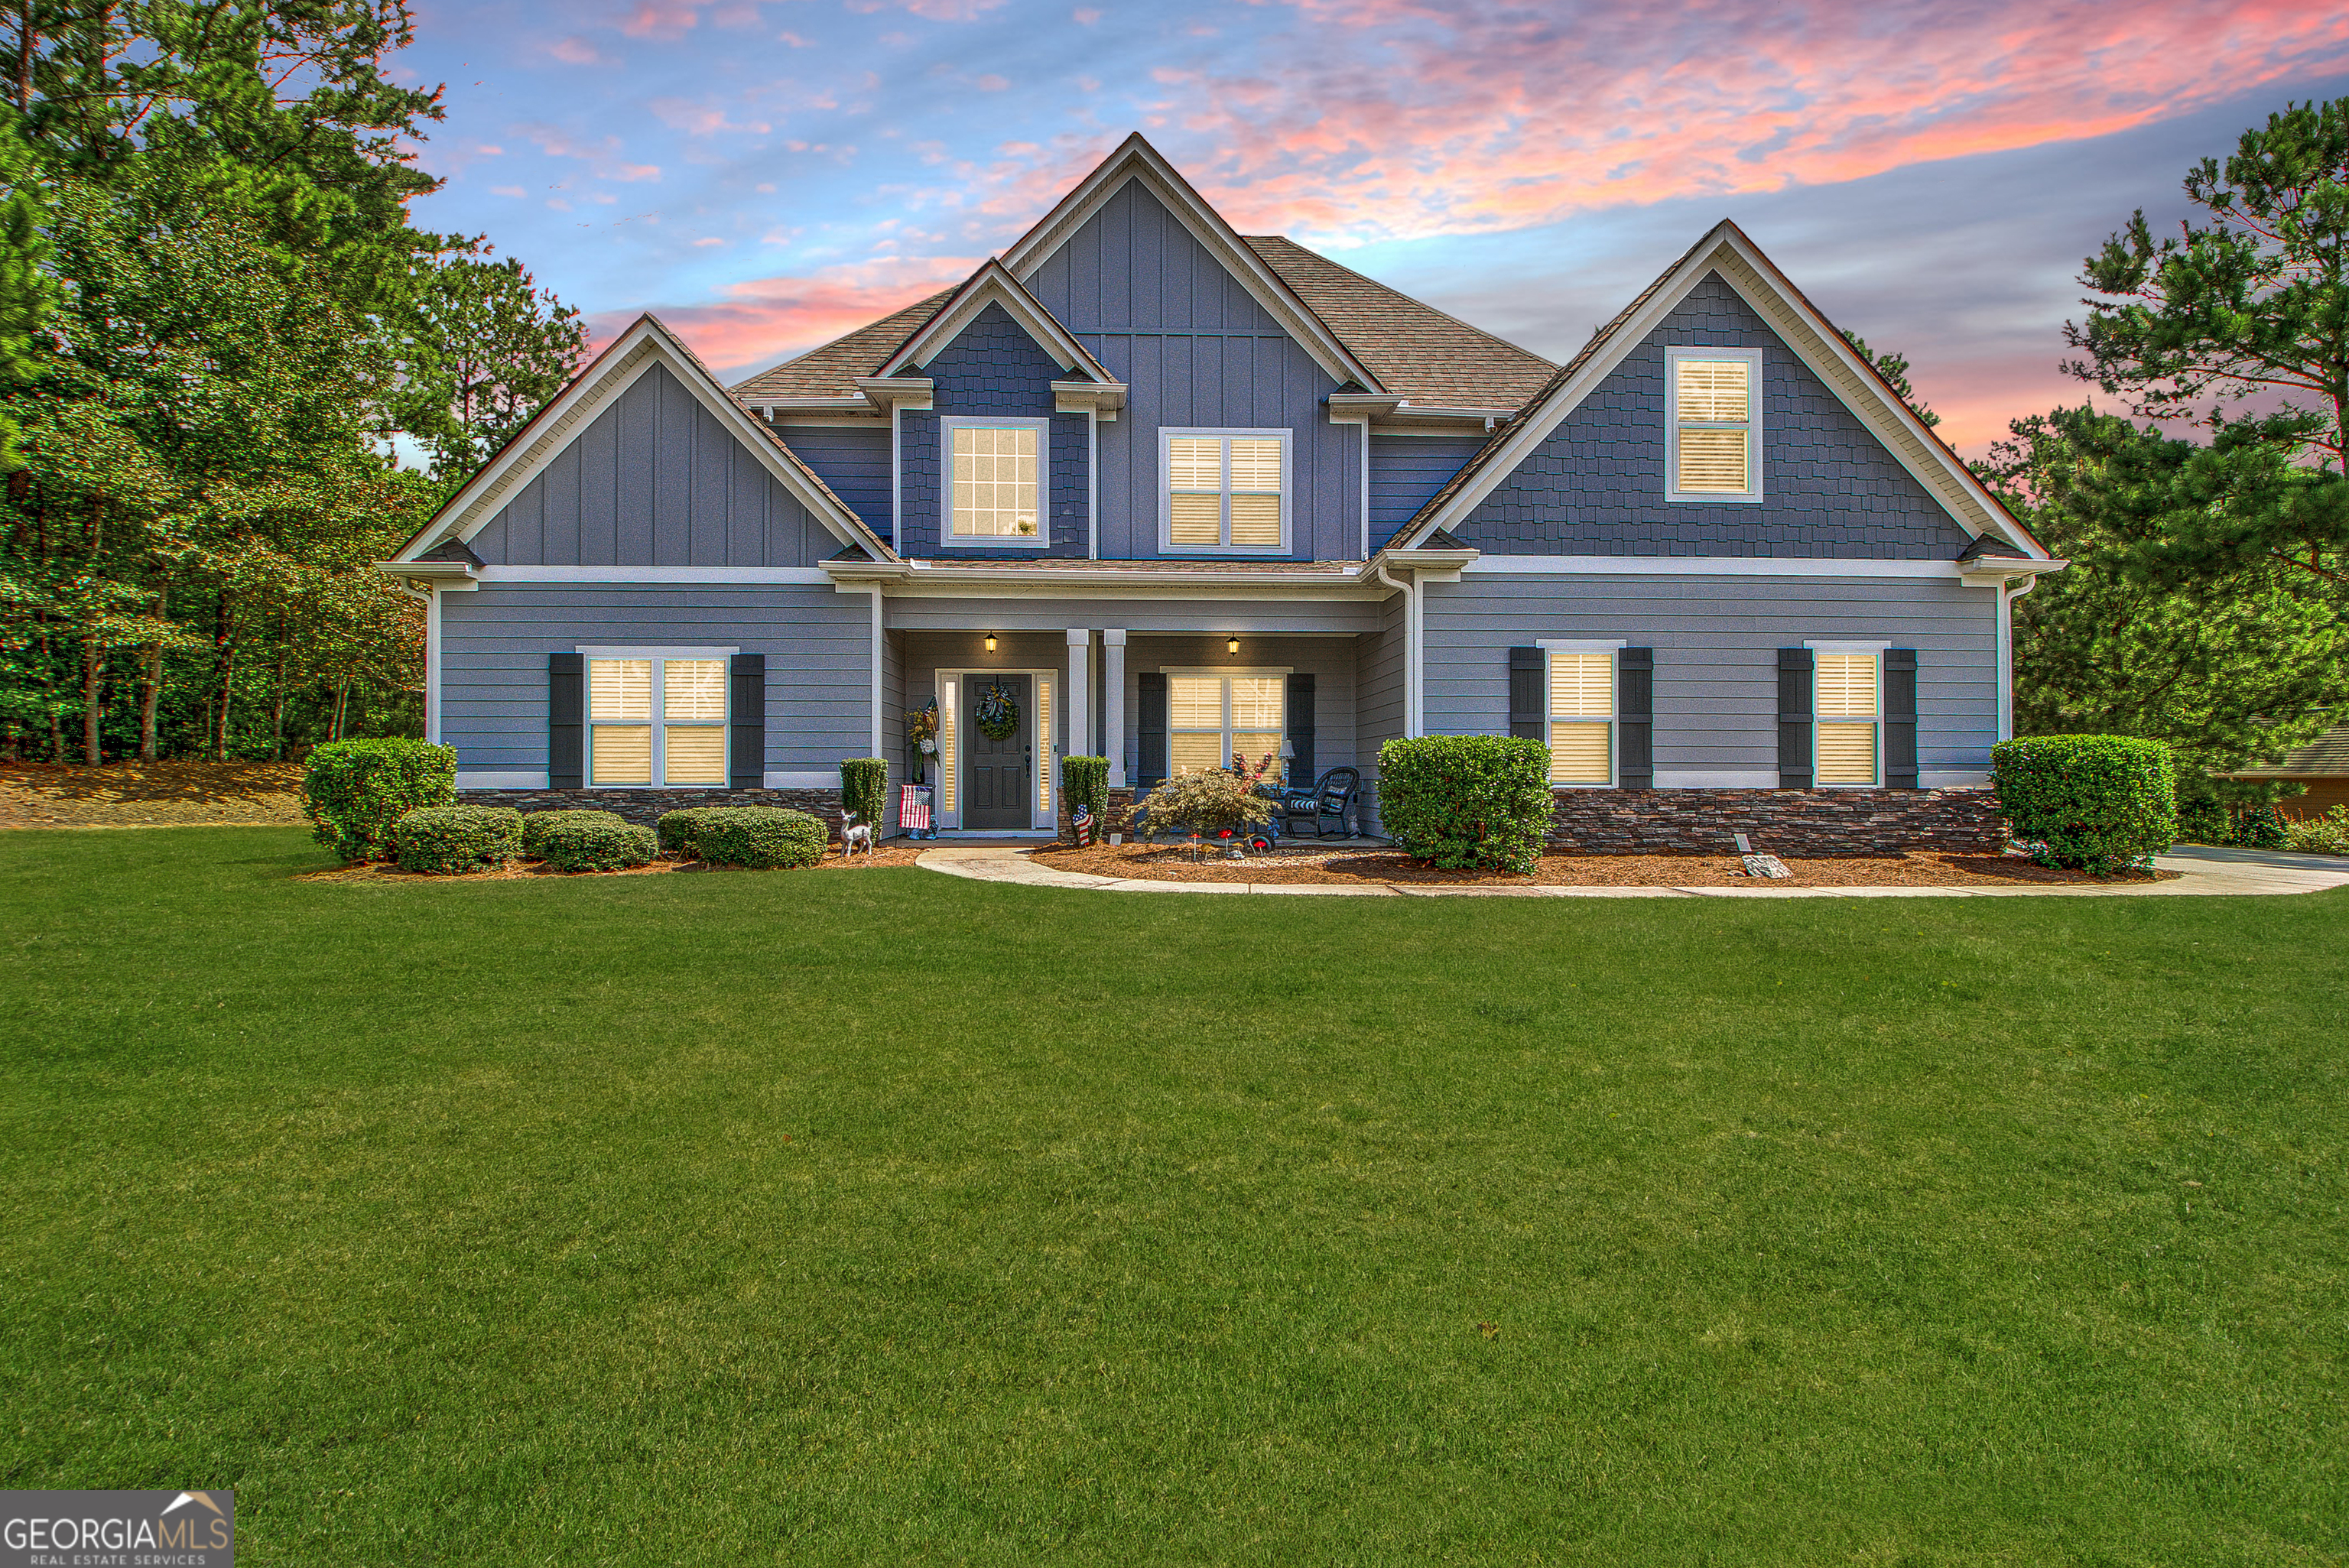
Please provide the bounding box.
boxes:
[439,582,872,777]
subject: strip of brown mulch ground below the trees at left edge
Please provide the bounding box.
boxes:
[0,763,303,829]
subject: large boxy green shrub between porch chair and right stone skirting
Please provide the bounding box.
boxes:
[1379,735,1551,875]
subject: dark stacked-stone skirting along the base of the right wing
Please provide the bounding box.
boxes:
[1551,789,2006,855]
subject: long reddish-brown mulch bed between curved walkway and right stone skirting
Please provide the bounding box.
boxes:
[1036,845,2178,888]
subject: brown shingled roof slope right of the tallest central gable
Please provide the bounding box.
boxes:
[1245,235,1558,408]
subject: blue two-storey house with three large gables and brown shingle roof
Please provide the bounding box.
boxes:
[385,136,2062,849]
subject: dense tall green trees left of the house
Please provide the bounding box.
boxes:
[0,0,585,763]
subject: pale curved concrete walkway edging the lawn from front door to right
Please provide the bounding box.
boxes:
[916,845,2349,899]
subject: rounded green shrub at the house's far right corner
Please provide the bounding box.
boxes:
[1990,735,2178,875]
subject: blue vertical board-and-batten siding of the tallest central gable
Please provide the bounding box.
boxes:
[1022,180,1363,561]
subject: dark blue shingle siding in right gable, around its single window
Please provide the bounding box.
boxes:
[1451,274,1970,561]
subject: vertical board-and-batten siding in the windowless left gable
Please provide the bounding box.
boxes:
[467,364,841,566]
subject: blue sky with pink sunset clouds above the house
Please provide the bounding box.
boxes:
[397,0,2349,456]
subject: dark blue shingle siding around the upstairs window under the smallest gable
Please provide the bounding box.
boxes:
[898,305,1090,557]
